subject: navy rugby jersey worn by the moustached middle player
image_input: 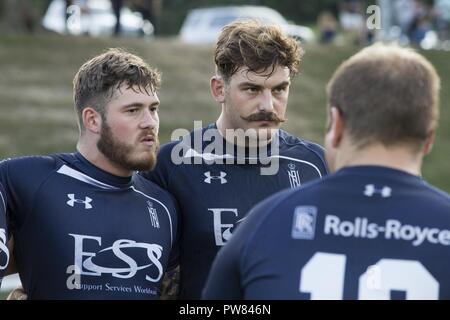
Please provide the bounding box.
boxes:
[144,124,327,299]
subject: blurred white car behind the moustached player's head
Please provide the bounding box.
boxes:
[180,6,315,44]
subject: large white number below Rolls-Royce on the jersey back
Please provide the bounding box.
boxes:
[299,252,439,300]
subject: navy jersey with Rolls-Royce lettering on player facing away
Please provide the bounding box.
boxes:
[203,166,450,299]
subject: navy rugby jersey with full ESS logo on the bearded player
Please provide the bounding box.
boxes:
[0,153,178,299]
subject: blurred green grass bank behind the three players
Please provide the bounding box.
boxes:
[0,34,450,192]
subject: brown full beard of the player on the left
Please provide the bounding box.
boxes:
[97,121,159,171]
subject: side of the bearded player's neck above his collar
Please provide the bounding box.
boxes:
[77,141,133,177]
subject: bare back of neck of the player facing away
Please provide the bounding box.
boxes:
[337,144,422,175]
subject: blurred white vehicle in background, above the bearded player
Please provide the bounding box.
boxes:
[42,0,154,37]
